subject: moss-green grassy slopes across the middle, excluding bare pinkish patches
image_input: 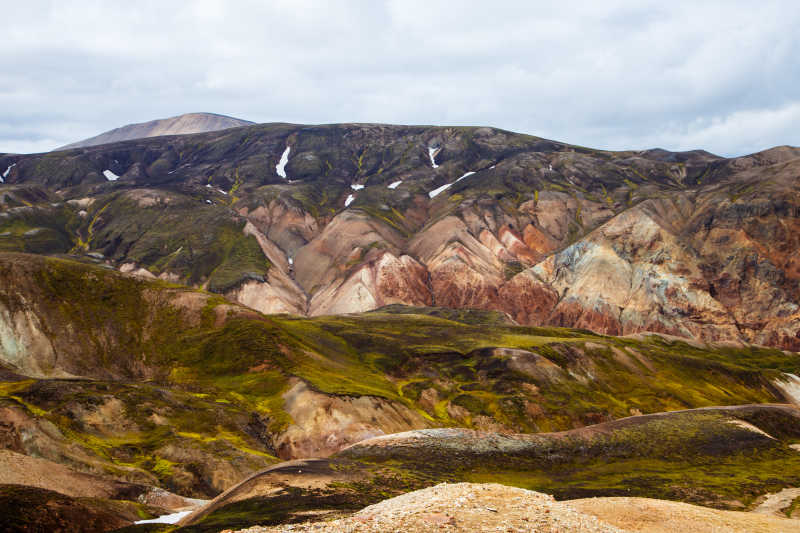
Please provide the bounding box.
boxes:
[0,256,800,508]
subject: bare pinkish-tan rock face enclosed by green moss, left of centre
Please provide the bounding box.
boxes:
[274,380,430,459]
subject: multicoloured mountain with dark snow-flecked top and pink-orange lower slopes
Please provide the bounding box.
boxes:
[0,119,800,350]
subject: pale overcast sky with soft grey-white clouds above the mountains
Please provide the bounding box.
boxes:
[0,0,800,156]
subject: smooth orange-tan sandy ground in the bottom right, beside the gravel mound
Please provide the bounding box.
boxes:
[564,498,800,533]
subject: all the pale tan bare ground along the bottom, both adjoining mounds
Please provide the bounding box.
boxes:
[223,483,798,533]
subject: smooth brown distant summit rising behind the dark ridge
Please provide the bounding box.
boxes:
[55,113,254,151]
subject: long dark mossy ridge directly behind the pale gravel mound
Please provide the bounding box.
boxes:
[180,405,800,533]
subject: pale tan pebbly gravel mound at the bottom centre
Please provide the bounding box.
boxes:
[228,483,623,533]
